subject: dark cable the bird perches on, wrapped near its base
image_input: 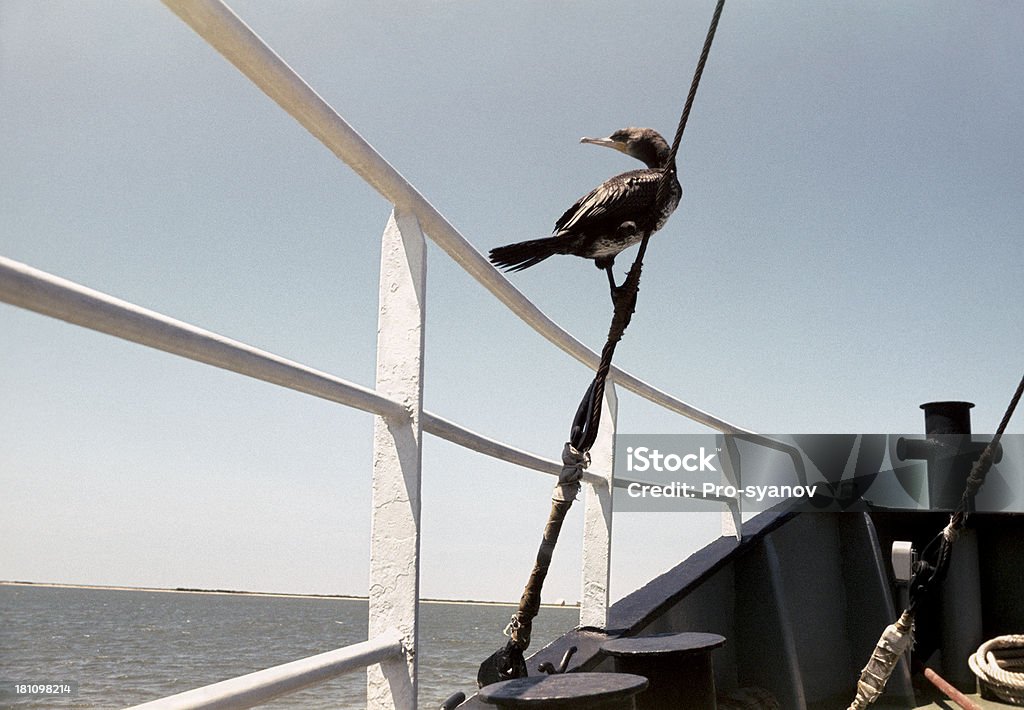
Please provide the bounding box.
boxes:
[476,0,725,687]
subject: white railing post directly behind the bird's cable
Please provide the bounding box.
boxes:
[580,381,618,629]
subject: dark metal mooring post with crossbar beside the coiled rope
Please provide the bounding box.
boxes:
[896,402,1002,691]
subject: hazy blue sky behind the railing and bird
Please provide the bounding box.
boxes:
[0,0,1024,600]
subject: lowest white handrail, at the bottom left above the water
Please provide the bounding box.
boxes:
[124,630,404,710]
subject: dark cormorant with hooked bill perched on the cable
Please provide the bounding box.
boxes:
[489,128,683,295]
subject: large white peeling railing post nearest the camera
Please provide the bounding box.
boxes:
[367,207,426,710]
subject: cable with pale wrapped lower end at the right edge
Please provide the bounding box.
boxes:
[848,370,1024,710]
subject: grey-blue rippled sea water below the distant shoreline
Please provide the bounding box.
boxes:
[0,585,579,710]
